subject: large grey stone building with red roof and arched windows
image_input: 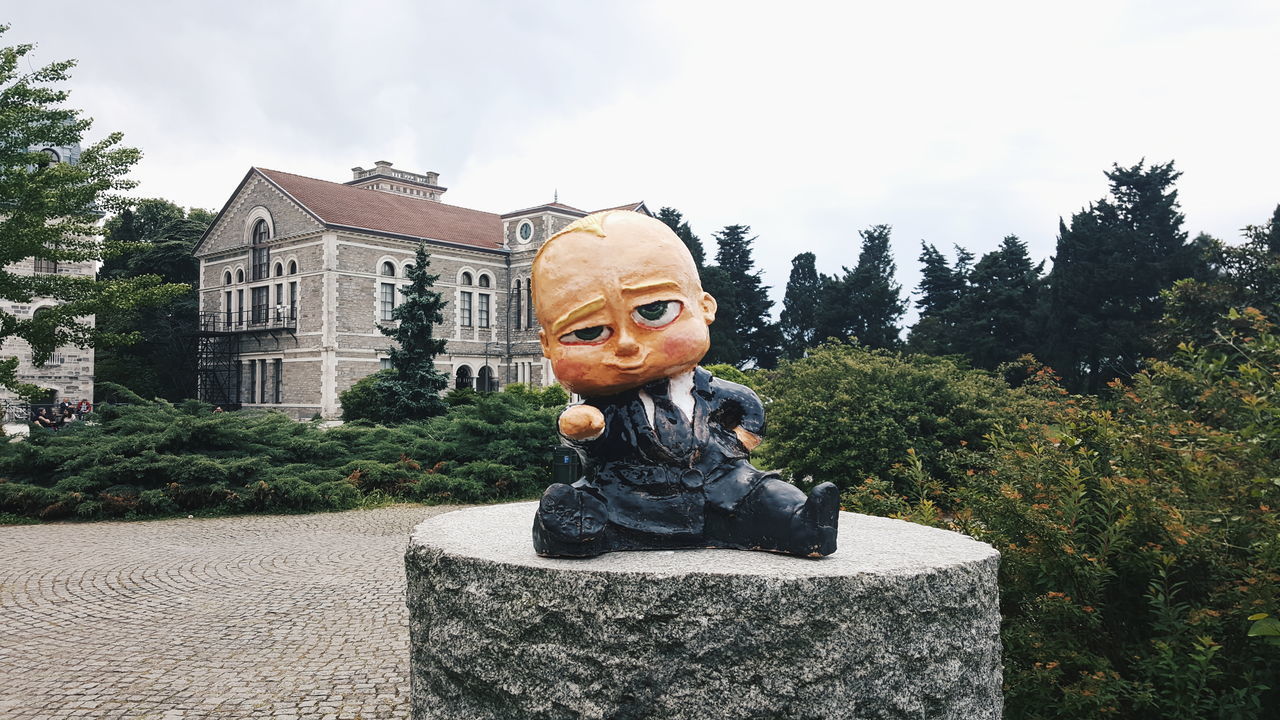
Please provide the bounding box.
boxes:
[195,161,649,418]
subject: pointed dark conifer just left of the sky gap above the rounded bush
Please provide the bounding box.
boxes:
[818,225,906,347]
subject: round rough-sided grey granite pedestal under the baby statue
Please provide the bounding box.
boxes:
[406,502,1001,720]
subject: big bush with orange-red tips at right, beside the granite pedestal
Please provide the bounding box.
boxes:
[844,310,1280,720]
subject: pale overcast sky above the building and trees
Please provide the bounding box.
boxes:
[10,0,1280,319]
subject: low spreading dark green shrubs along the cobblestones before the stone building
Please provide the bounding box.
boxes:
[0,388,564,520]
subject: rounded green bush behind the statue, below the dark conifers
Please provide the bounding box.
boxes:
[759,343,1041,491]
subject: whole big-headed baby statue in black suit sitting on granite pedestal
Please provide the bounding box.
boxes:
[531,210,840,557]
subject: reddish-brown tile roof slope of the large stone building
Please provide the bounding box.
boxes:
[256,168,502,250]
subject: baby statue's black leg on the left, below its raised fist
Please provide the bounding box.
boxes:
[534,483,613,557]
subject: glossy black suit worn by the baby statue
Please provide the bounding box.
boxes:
[534,368,838,555]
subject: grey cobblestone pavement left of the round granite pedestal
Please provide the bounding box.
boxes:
[0,505,451,720]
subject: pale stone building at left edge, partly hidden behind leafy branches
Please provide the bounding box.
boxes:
[0,145,97,409]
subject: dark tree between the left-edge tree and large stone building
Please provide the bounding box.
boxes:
[95,199,214,401]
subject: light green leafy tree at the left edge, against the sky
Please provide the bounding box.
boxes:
[0,26,187,392]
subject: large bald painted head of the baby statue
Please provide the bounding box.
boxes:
[532,214,716,396]
